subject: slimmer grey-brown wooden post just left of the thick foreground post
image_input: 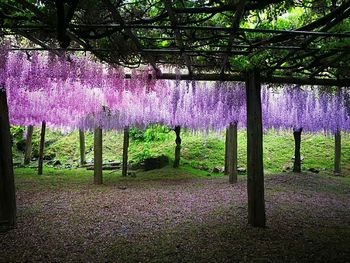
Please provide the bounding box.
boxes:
[227,123,237,184]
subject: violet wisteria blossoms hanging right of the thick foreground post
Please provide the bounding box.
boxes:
[262,86,350,133]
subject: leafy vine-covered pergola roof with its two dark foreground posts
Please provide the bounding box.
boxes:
[0,0,350,230]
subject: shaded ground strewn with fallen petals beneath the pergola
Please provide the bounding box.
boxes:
[0,167,350,262]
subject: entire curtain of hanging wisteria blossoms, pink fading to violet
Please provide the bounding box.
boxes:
[0,46,350,132]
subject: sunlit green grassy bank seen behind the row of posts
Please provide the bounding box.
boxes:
[14,129,350,172]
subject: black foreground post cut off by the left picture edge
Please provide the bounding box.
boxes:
[0,87,16,230]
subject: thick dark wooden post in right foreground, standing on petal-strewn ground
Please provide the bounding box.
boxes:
[246,69,266,227]
